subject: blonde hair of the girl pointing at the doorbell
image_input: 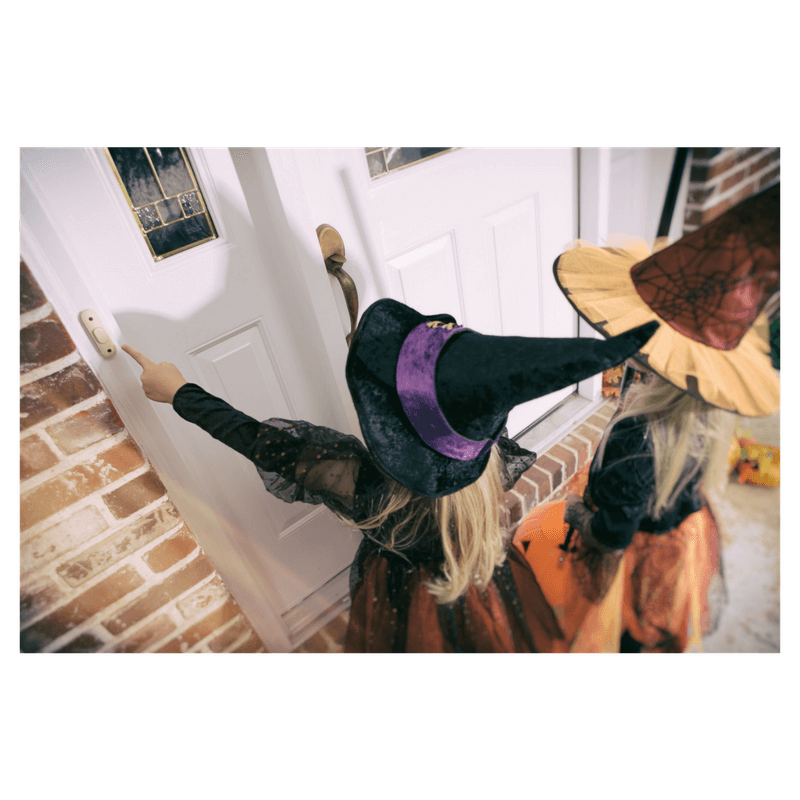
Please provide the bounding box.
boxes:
[359,445,506,604]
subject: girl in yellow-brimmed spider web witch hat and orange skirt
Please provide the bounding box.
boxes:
[515,184,781,653]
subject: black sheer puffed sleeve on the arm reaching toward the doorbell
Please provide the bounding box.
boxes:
[173,384,382,521]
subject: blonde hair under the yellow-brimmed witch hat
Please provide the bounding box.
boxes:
[597,373,736,519]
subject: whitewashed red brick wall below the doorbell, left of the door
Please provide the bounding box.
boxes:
[18,263,265,654]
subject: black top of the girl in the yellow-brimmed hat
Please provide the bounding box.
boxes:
[587,417,703,549]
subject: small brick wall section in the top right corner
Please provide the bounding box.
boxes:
[683,147,781,235]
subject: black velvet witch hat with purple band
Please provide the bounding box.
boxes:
[346,299,658,497]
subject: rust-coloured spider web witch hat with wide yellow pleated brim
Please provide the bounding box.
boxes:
[553,184,781,417]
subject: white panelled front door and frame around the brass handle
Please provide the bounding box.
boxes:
[20,147,577,651]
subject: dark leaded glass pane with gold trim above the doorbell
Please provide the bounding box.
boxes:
[106,145,217,261]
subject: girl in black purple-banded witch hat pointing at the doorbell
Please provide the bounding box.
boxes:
[123,299,658,653]
